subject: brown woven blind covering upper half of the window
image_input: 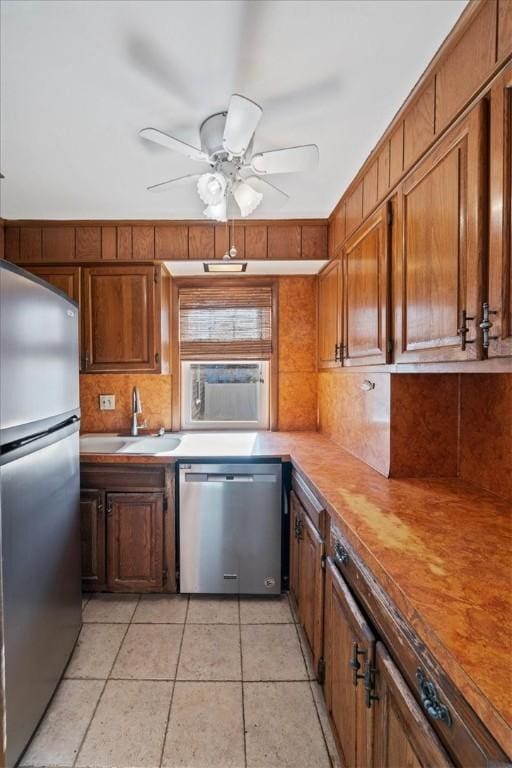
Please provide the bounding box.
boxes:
[179,286,272,360]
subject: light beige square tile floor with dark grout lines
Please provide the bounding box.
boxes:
[21,595,338,768]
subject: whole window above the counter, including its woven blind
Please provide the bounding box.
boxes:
[178,281,273,429]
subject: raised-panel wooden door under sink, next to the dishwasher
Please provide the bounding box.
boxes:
[107,493,163,592]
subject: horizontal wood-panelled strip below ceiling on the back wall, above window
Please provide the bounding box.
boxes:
[5,219,328,263]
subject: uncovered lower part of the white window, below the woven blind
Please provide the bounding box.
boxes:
[181,360,269,429]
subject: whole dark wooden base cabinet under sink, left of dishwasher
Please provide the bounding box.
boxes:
[80,462,171,593]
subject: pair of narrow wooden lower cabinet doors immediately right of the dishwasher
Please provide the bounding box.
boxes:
[290,491,325,678]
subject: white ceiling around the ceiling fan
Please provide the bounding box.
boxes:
[0,0,466,219]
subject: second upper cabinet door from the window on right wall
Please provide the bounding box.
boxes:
[343,205,389,366]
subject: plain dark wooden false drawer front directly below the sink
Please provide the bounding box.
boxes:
[80,464,165,493]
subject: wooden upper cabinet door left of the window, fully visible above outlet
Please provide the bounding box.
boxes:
[83,266,160,372]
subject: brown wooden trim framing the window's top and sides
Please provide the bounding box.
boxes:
[171,274,279,432]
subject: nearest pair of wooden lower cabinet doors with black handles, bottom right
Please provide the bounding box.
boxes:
[325,558,453,768]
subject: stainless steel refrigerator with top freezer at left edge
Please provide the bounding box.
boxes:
[0,261,81,768]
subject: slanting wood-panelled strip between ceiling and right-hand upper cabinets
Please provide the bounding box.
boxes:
[329,0,512,246]
